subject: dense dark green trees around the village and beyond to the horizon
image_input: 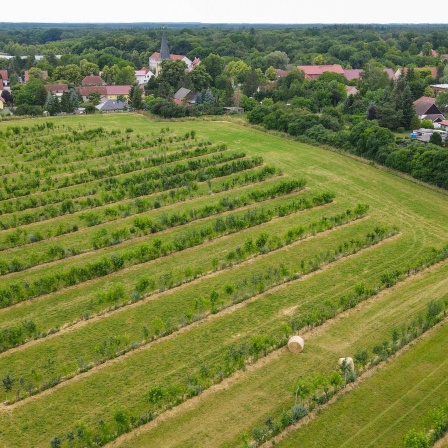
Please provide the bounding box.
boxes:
[0,24,448,187]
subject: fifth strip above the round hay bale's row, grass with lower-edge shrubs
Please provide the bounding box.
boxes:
[2,175,298,272]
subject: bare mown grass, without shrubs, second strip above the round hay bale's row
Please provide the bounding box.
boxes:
[0,221,384,392]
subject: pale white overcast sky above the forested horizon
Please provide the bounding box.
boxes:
[0,0,448,26]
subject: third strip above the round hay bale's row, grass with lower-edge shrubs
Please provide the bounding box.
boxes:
[0,203,360,350]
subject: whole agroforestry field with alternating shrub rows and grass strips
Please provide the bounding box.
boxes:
[0,114,448,448]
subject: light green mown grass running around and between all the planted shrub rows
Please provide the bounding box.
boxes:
[0,114,448,448]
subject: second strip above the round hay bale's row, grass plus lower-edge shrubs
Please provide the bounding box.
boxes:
[0,217,392,396]
